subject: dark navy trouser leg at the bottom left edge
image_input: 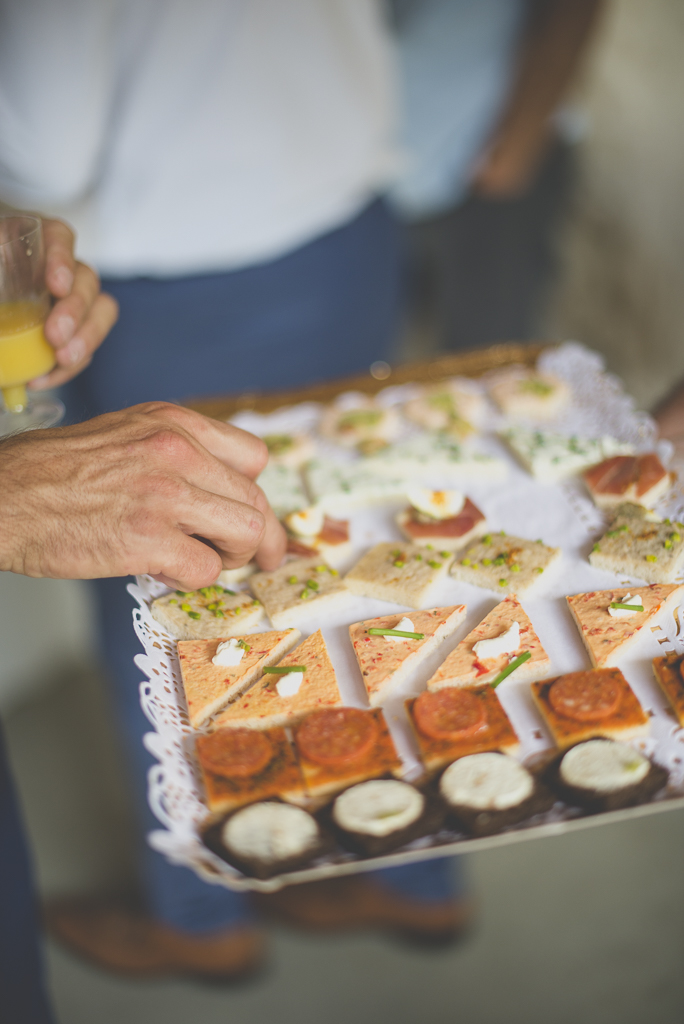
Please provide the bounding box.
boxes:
[0,731,53,1024]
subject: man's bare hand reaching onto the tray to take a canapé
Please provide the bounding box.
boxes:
[0,402,286,590]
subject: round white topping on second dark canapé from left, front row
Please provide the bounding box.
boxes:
[333,779,425,836]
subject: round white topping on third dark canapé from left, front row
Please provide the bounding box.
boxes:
[439,754,535,811]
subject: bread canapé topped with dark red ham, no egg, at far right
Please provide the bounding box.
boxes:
[583,452,674,509]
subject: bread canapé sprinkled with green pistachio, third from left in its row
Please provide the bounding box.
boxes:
[344,543,453,608]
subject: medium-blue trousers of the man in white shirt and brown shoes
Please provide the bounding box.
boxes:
[67,201,462,932]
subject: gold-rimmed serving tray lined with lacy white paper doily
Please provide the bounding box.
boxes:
[128,343,684,892]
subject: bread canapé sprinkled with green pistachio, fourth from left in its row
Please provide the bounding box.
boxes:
[452,531,561,595]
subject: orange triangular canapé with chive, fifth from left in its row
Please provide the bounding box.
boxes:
[566,583,684,669]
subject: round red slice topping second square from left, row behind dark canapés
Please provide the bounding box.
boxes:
[296,708,378,765]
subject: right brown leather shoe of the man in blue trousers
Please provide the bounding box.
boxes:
[252,874,475,945]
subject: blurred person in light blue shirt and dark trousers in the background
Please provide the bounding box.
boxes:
[391,0,602,349]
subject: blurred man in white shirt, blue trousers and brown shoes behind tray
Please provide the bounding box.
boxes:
[0,0,471,978]
